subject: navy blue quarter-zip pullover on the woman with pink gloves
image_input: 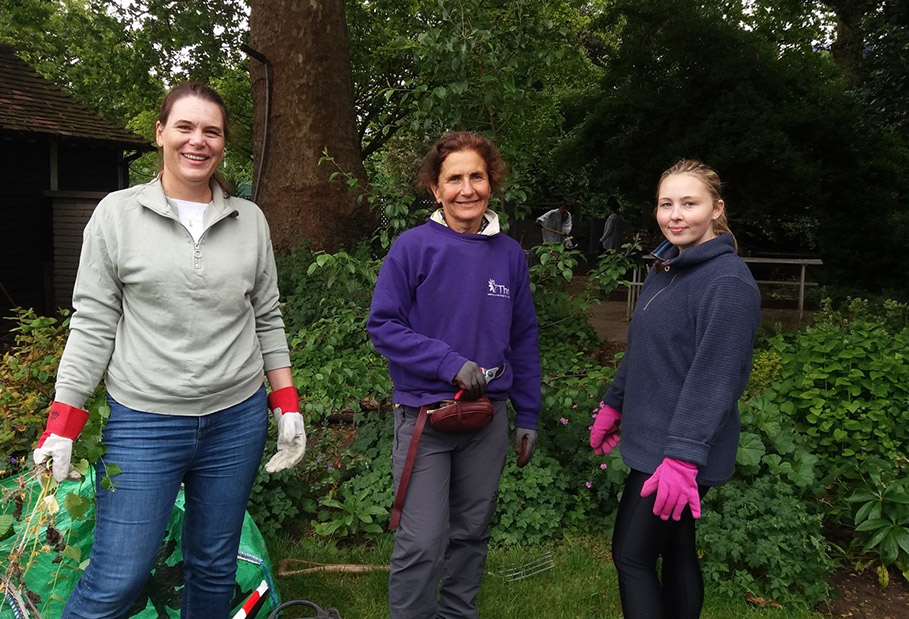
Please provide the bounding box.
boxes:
[604,234,761,486]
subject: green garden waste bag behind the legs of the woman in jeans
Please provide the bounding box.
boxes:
[0,471,280,619]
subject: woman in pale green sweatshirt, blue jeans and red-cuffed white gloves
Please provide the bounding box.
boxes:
[34,82,306,619]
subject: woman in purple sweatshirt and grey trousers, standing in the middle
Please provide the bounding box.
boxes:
[368,132,540,619]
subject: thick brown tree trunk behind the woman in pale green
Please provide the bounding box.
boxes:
[249,0,375,254]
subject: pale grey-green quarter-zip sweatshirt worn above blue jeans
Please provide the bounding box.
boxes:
[56,179,290,416]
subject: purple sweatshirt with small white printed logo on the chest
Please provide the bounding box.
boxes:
[367,221,541,429]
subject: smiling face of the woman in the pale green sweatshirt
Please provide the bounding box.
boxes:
[155,96,224,202]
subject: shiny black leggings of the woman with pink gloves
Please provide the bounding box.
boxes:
[612,470,707,619]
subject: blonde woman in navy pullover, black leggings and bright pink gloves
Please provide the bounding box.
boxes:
[590,160,761,619]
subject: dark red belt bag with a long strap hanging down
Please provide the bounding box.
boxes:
[388,395,495,530]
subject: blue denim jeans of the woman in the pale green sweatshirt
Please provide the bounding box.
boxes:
[63,387,268,619]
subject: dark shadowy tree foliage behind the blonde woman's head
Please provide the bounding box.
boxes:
[558,0,909,290]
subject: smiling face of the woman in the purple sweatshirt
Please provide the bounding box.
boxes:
[430,150,492,234]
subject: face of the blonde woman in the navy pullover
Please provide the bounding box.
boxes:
[656,174,724,251]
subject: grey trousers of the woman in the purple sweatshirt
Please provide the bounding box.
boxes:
[388,401,509,619]
